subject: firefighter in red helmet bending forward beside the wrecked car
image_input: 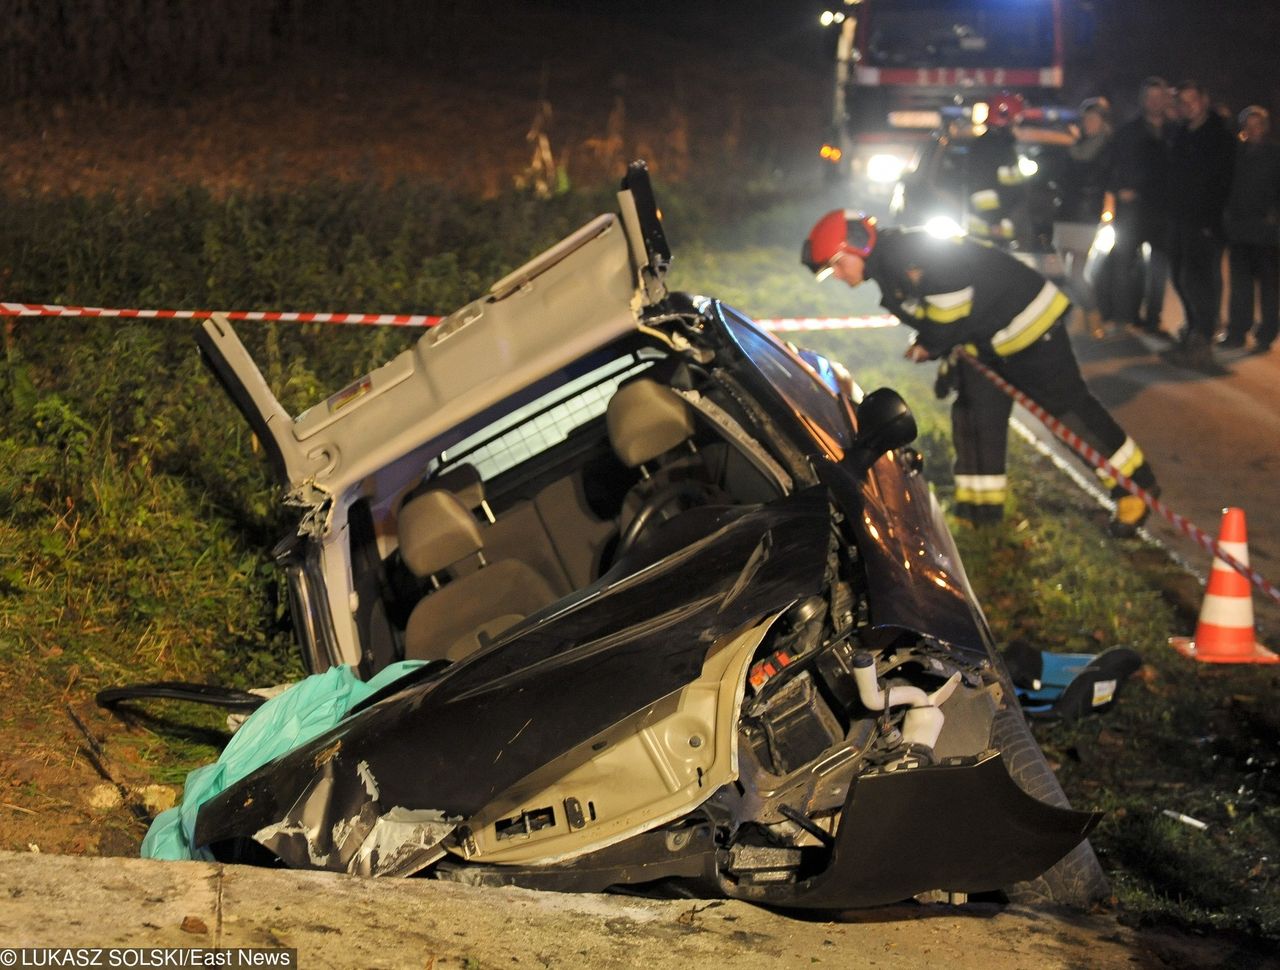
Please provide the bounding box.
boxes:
[801,209,1160,537]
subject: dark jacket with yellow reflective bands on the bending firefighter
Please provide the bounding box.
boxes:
[865,229,1070,358]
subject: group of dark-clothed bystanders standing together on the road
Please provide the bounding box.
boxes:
[1064,77,1280,374]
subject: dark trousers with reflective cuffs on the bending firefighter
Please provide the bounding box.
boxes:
[951,319,1156,522]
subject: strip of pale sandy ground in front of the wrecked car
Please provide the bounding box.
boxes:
[0,852,1276,970]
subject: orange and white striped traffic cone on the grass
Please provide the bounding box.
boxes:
[1169,508,1280,663]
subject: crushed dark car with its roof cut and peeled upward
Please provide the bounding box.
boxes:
[192,164,1105,909]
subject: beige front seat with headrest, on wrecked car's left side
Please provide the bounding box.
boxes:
[399,489,556,660]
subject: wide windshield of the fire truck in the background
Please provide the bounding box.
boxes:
[861,0,1055,68]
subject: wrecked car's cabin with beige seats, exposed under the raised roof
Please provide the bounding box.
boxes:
[349,349,785,667]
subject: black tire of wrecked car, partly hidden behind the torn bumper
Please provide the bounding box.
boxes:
[991,691,1111,910]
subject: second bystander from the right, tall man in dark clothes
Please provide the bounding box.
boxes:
[1169,81,1235,372]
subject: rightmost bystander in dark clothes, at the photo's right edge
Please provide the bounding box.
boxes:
[1220,105,1280,353]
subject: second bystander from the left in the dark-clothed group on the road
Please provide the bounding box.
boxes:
[1100,77,1170,334]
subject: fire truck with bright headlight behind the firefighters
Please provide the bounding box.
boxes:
[822,0,1064,211]
